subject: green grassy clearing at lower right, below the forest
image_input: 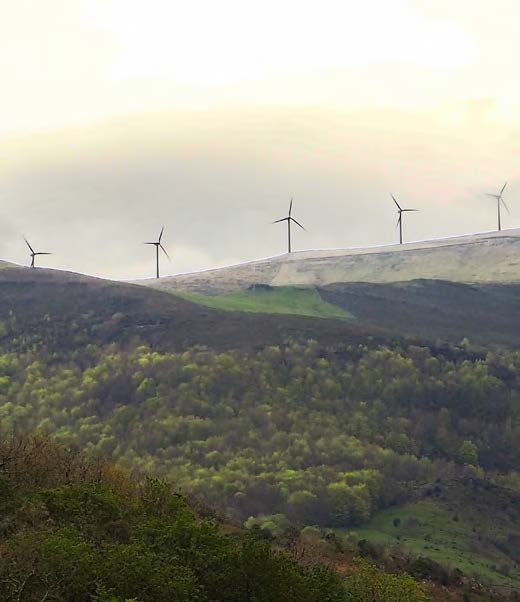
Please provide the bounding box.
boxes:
[356,501,520,589]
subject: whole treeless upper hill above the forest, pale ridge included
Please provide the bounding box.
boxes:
[0,230,520,350]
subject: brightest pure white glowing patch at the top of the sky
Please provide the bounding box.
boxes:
[91,0,477,86]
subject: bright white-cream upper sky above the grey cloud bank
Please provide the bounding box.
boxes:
[0,0,500,131]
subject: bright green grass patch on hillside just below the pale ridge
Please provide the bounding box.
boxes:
[174,286,352,320]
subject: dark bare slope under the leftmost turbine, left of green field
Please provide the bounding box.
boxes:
[0,267,388,351]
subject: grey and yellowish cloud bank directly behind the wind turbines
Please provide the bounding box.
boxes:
[0,104,520,278]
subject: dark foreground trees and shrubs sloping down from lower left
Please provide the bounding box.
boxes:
[0,435,427,602]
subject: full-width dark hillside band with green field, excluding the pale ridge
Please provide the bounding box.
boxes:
[0,251,520,351]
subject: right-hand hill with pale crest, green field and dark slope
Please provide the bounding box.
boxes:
[125,229,520,346]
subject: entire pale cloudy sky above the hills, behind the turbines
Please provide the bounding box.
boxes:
[0,0,520,279]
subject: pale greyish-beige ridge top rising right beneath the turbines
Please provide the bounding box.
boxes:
[137,229,520,295]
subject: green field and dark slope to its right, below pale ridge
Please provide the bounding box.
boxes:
[160,280,520,346]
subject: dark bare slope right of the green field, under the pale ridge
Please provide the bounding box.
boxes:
[319,280,520,347]
